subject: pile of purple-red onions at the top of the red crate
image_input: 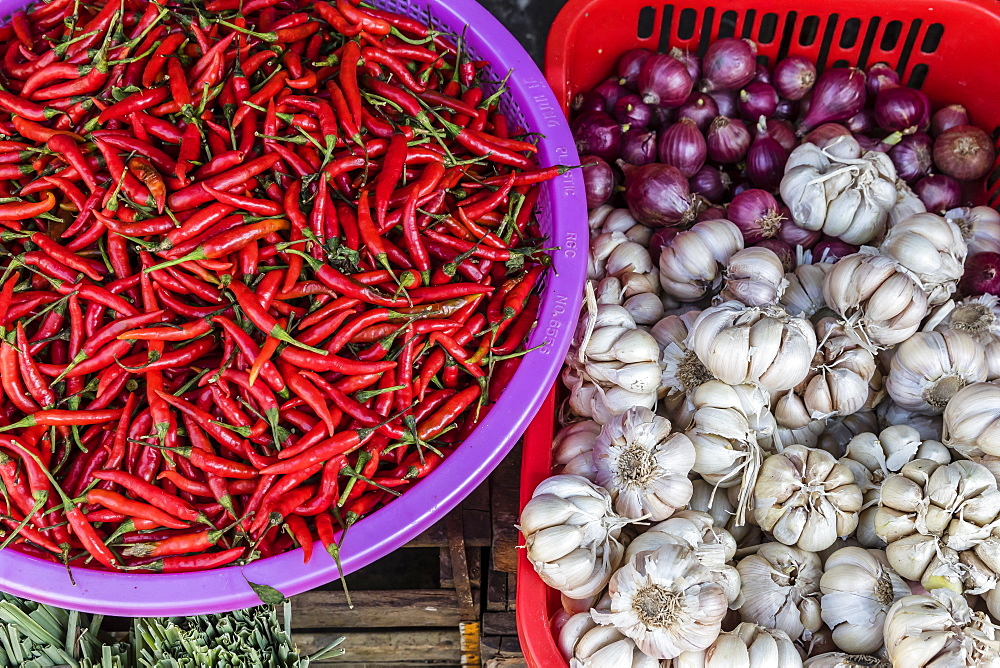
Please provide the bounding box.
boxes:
[571,38,1000,290]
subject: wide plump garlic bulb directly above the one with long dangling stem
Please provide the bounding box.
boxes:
[688,301,816,391]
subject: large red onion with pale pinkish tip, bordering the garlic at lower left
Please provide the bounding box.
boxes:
[618,160,698,227]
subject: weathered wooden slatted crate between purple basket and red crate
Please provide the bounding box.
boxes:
[292,447,524,668]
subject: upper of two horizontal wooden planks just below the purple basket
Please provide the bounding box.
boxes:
[292,589,459,629]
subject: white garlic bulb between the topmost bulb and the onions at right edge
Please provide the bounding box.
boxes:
[879,213,966,306]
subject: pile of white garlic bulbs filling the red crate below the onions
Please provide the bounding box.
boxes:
[520,194,1000,668]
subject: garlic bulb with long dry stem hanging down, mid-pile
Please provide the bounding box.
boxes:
[687,380,774,525]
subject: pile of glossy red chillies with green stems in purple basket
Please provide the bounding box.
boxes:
[0,0,565,572]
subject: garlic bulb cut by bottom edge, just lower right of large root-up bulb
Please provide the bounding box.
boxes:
[673,622,802,668]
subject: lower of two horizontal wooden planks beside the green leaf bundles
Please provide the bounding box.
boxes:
[292,626,461,668]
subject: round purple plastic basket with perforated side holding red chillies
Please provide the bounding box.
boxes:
[0,0,588,616]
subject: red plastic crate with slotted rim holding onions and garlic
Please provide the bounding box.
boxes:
[517,0,1000,668]
